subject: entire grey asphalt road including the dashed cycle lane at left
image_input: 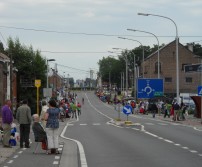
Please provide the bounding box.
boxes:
[0,92,202,167]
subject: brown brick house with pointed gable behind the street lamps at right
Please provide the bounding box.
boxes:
[141,40,201,96]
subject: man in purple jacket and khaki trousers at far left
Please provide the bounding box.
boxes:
[2,100,13,148]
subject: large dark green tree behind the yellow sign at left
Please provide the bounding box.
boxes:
[6,37,46,112]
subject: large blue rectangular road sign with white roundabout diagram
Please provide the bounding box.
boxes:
[137,78,164,99]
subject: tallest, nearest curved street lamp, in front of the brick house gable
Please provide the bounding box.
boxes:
[138,13,180,103]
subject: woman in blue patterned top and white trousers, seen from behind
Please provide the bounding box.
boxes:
[45,99,60,154]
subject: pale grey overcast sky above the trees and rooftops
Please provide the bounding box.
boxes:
[0,0,202,79]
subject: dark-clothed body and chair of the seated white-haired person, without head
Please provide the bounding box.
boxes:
[32,122,48,154]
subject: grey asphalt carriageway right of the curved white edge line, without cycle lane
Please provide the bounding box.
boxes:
[65,93,202,167]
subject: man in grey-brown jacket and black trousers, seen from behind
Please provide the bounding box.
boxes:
[16,100,32,148]
